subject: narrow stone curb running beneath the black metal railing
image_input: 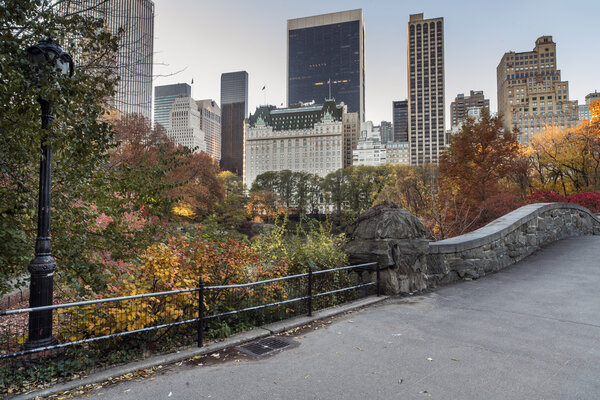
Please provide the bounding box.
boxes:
[12,295,389,400]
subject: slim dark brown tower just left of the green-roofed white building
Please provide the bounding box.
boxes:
[221,71,248,176]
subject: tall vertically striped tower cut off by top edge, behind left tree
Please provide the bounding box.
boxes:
[57,0,154,119]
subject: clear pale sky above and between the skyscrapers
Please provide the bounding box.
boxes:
[154,0,600,124]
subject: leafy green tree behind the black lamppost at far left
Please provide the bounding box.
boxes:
[0,0,123,293]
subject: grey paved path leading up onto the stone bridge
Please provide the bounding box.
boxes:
[74,236,600,400]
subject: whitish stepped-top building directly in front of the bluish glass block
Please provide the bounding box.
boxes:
[167,97,206,152]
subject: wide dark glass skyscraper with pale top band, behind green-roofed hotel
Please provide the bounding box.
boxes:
[287,9,365,121]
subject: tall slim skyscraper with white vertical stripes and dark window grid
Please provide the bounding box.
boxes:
[408,14,446,165]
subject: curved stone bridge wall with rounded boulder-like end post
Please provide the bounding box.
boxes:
[346,203,600,294]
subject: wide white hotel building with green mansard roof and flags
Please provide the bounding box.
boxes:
[243,100,346,188]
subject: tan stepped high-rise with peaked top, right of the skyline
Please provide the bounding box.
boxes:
[496,36,579,143]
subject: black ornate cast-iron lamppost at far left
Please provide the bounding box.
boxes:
[23,38,74,349]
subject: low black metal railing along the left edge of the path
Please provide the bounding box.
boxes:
[0,262,381,360]
